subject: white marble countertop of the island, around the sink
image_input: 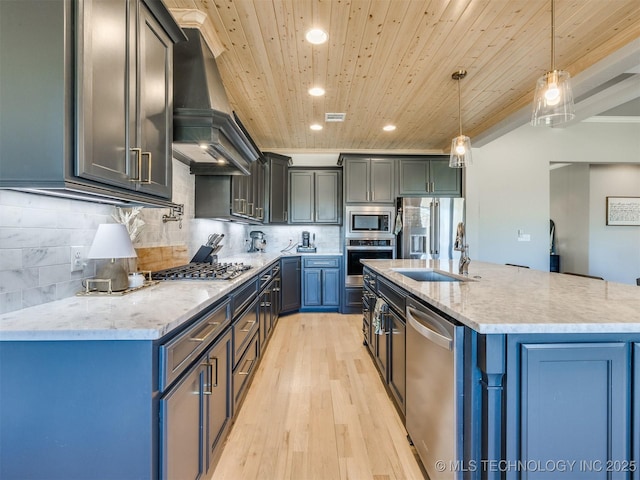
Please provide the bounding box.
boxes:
[363,260,640,334]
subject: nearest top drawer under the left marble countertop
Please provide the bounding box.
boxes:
[160,300,231,391]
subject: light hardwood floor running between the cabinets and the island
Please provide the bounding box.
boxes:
[212,313,425,480]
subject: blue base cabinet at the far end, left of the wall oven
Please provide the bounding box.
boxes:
[301,256,342,311]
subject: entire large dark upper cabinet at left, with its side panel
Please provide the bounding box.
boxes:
[0,0,184,205]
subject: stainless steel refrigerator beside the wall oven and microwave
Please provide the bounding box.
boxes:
[396,197,464,260]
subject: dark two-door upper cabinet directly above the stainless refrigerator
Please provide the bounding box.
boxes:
[399,155,462,197]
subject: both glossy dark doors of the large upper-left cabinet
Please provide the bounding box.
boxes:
[77,1,173,198]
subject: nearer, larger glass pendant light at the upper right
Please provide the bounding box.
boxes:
[531,0,575,127]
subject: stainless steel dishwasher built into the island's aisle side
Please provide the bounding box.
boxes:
[405,298,464,480]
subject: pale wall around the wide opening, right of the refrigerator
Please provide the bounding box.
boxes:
[465,118,640,280]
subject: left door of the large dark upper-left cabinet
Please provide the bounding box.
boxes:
[75,0,131,189]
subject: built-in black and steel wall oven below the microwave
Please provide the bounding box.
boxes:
[345,235,396,287]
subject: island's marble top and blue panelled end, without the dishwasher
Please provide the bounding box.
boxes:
[363,260,640,479]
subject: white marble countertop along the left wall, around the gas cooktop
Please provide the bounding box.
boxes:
[0,253,281,341]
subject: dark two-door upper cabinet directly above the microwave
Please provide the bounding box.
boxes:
[340,155,396,204]
